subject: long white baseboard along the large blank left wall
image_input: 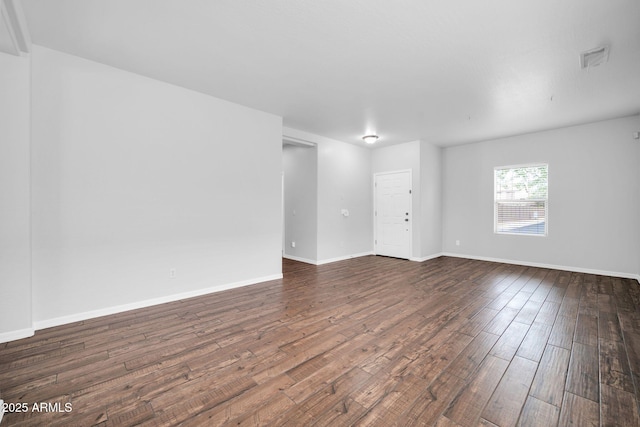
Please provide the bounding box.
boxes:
[34,273,282,330]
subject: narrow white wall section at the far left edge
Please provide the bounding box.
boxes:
[0,53,33,342]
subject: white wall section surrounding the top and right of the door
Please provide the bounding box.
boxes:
[372,141,422,259]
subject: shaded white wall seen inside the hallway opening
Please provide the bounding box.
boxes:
[282,145,318,263]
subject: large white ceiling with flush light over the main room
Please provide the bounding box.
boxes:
[23,0,640,146]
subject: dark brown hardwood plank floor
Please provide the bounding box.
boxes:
[0,256,640,427]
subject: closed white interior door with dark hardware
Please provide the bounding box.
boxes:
[374,170,412,259]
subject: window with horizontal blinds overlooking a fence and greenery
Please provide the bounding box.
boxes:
[494,165,548,236]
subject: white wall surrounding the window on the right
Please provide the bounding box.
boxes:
[443,116,640,275]
